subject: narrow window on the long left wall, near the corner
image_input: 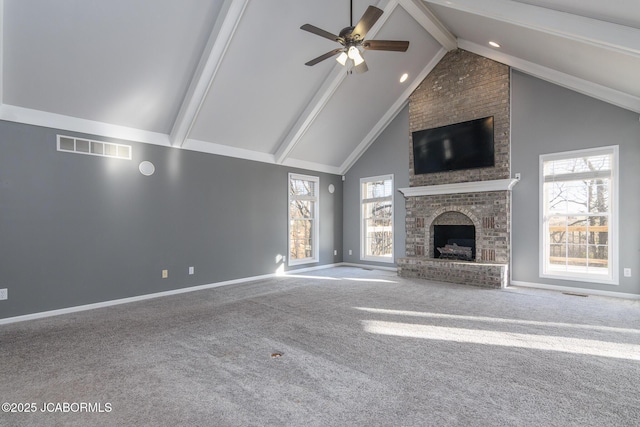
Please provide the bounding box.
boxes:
[289,173,319,265]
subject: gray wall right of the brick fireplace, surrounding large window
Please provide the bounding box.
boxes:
[511,71,640,294]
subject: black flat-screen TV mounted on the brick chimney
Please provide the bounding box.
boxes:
[411,116,495,175]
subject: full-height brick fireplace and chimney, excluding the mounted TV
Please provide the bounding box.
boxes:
[397,49,517,288]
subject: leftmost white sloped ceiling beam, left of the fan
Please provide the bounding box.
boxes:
[169,0,249,147]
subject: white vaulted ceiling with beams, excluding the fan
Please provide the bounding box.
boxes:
[0,0,640,174]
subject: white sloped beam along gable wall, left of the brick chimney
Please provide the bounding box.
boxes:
[340,46,447,175]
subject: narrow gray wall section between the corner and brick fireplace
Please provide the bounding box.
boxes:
[343,106,409,267]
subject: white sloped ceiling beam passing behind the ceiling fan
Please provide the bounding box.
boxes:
[274,0,398,164]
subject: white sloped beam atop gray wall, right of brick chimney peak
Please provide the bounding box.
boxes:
[458,40,640,113]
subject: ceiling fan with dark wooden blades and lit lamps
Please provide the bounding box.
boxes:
[300,0,409,73]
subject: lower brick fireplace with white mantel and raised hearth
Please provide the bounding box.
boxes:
[398,179,517,288]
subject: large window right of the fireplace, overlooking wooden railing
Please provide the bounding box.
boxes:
[540,146,618,284]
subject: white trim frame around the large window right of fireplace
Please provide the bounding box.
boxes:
[538,145,620,285]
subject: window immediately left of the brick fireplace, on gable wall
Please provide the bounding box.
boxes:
[360,175,393,262]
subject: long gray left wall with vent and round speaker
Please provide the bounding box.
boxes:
[0,121,343,318]
